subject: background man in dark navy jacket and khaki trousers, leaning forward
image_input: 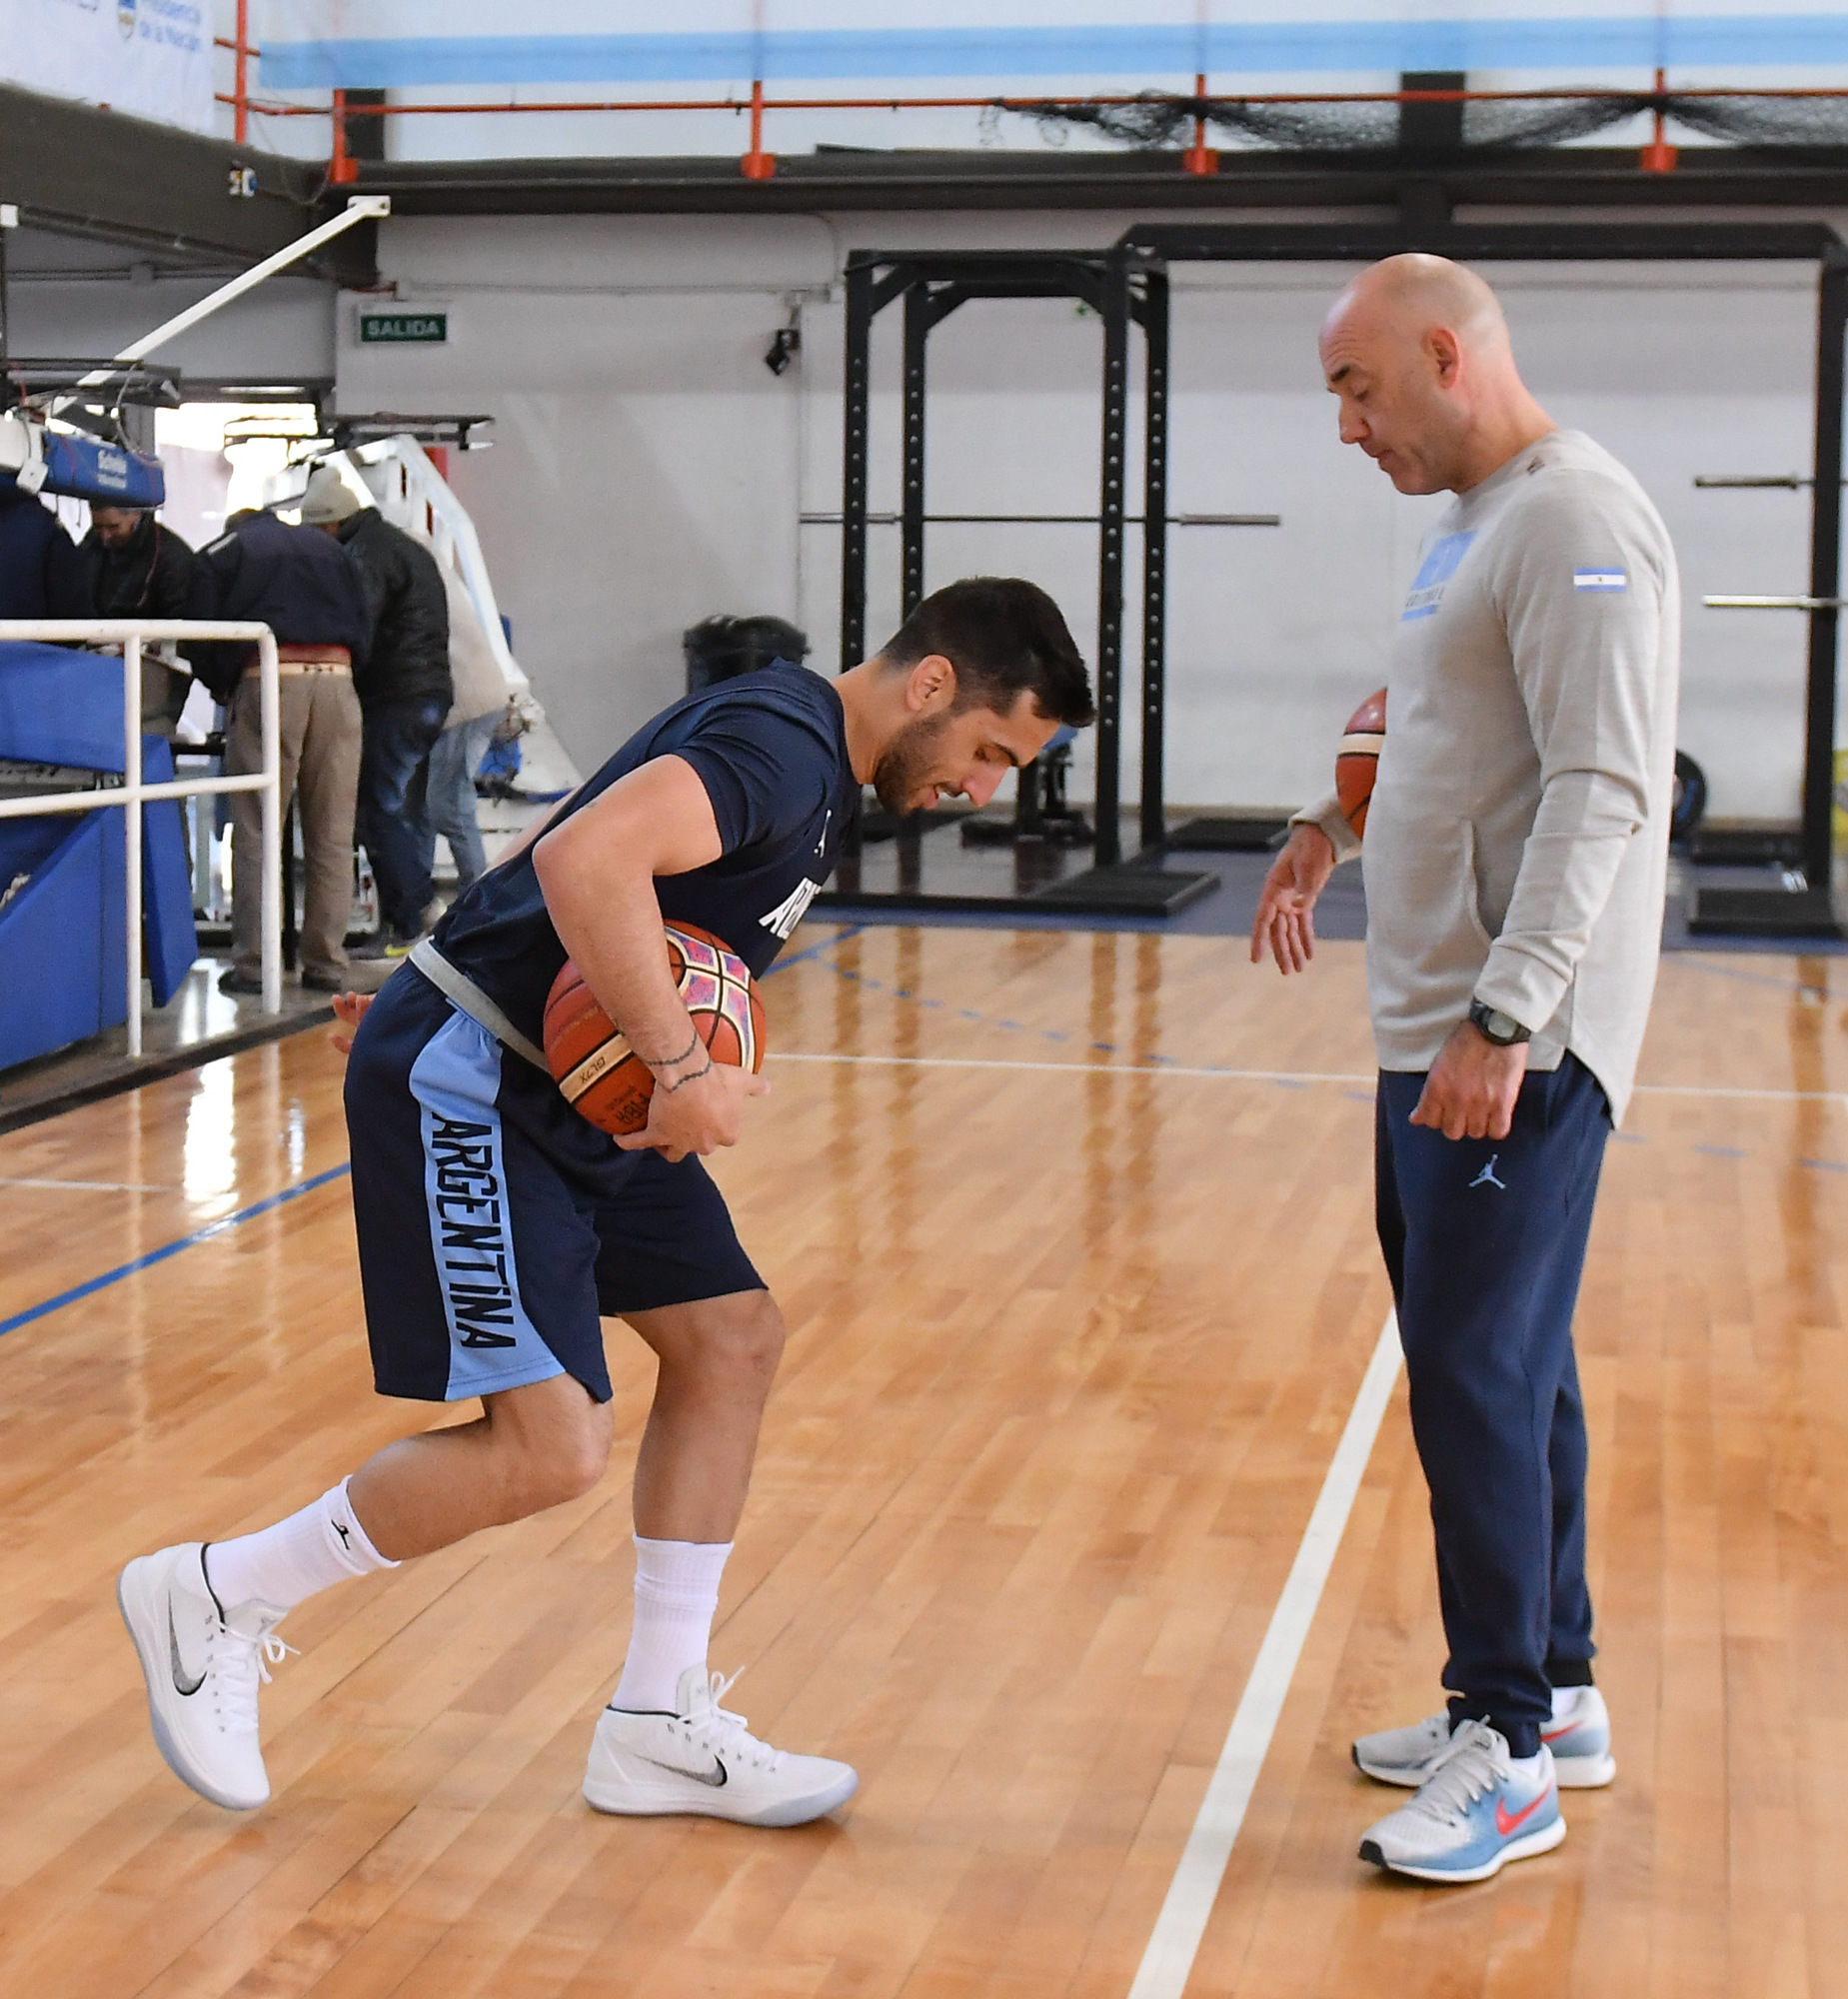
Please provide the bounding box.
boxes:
[188,512,372,994]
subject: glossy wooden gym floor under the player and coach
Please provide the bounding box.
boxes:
[0,926,1848,1999]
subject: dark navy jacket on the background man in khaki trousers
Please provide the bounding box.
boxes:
[186,514,372,700]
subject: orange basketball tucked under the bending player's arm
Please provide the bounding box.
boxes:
[544,924,764,1135]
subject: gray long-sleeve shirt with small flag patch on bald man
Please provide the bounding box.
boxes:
[1298,432,1680,1119]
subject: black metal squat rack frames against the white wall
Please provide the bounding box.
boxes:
[818,220,1848,938]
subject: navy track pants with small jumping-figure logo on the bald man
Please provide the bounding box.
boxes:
[1374,1055,1610,1755]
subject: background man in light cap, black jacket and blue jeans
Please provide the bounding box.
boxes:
[302,466,454,958]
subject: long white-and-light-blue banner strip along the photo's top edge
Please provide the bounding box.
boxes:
[262,0,1848,90]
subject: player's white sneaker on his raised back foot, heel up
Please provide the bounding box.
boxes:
[116,1541,290,1811]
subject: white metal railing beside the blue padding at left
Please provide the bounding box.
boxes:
[0,618,282,1055]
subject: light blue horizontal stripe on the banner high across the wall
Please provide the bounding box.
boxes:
[258,10,1848,90]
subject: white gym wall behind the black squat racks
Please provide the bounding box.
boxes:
[336,216,1812,816]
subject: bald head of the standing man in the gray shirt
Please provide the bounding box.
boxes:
[1322,254,1554,494]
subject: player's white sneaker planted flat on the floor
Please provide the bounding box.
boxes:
[584,1665,860,1825]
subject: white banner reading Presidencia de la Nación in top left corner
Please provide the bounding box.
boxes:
[0,0,212,132]
